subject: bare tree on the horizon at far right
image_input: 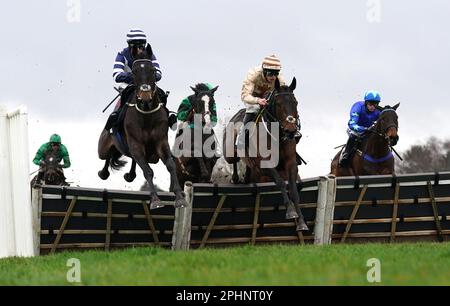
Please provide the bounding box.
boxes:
[395,137,450,173]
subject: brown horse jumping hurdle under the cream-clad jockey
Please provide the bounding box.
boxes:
[223,78,308,231]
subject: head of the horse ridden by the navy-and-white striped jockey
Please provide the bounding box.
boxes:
[132,45,157,102]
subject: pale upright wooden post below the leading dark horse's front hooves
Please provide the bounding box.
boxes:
[172,182,194,250]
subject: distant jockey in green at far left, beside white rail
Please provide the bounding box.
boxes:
[33,134,70,185]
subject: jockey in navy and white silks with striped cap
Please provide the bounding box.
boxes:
[105,29,174,130]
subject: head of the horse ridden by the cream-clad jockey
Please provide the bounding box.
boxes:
[268,77,298,138]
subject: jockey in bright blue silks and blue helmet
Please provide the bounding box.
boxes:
[339,90,381,167]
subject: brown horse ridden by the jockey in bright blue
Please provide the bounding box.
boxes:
[331,103,400,176]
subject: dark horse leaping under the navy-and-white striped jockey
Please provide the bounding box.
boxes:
[98,48,187,209]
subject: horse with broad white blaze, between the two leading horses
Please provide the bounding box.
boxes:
[174,83,219,186]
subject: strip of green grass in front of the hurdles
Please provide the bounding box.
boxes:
[0,243,450,285]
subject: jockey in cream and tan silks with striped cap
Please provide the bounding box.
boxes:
[237,55,301,165]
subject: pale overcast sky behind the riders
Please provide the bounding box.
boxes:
[0,0,450,189]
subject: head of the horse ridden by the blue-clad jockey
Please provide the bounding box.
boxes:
[375,103,400,146]
